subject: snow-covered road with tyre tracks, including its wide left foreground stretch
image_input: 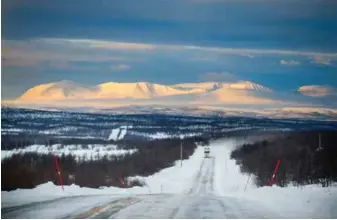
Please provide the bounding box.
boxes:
[1,154,279,218]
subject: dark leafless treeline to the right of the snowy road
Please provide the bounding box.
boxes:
[231,131,337,187]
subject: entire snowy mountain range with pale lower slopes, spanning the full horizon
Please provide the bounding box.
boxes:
[2,81,337,118]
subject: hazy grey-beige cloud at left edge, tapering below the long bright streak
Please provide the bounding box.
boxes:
[2,40,142,66]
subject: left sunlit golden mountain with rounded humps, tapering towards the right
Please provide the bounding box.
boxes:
[19,81,198,101]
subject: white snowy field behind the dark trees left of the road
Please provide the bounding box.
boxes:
[1,144,137,160]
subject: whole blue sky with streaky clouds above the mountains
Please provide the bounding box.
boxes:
[1,0,337,99]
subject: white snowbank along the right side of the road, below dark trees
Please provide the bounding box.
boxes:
[211,140,337,218]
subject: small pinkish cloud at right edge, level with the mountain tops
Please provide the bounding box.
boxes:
[297,85,337,97]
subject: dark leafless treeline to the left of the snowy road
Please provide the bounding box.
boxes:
[1,138,200,191]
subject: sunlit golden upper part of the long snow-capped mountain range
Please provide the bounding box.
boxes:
[18,81,271,102]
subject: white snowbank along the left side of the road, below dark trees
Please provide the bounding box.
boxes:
[1,147,203,207]
